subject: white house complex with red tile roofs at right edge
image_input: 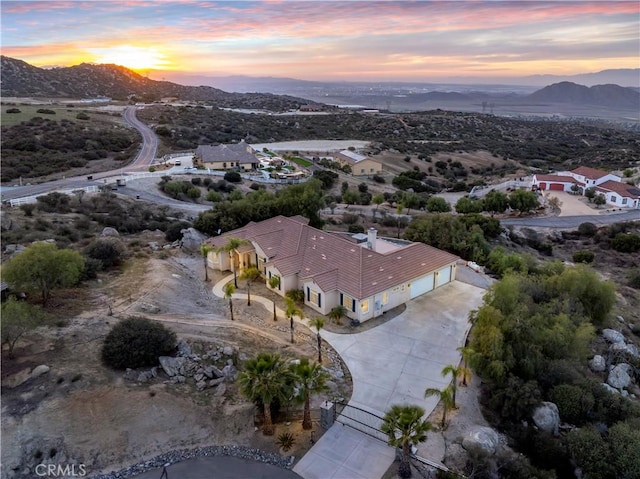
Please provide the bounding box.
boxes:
[532,166,640,208]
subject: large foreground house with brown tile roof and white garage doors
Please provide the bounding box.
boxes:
[202,216,459,321]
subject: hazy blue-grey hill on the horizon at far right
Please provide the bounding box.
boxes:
[527,82,640,111]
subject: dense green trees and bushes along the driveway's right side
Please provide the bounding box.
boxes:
[470,264,640,478]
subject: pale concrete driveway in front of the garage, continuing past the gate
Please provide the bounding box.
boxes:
[293,281,485,479]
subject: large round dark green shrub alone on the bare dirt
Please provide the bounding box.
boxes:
[102,317,176,369]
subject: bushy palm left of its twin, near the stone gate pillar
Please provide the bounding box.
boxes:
[238,353,291,436]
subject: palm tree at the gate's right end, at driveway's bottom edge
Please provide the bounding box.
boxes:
[380,404,432,477]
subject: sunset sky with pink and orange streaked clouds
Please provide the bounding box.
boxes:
[1,0,640,81]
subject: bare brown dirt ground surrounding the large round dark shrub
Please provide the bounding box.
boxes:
[2,251,351,478]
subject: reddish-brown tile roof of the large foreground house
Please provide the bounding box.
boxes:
[208,216,458,299]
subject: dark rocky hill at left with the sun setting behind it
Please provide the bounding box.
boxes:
[0,56,316,110]
